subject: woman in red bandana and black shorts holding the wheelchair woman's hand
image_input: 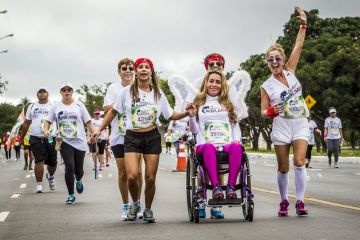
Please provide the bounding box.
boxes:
[93,58,188,223]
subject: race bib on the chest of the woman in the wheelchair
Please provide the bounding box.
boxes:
[205,121,230,143]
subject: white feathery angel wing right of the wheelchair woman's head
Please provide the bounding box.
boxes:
[229,70,251,120]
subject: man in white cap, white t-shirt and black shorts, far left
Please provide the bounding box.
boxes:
[20,87,57,193]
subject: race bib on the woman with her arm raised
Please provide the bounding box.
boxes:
[284,96,306,119]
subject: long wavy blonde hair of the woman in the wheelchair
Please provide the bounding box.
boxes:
[194,71,238,123]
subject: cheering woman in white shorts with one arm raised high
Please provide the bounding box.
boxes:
[261,7,310,216]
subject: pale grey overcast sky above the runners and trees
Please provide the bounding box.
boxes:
[0,0,360,103]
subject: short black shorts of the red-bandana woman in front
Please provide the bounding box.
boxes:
[124,128,162,154]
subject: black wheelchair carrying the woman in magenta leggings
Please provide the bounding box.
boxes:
[186,136,254,223]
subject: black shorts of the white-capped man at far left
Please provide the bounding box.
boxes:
[30,136,57,167]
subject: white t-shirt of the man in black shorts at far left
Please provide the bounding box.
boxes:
[25,102,56,137]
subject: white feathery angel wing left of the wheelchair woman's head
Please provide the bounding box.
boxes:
[168,75,198,112]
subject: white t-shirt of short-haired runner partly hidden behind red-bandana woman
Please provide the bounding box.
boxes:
[103,83,126,146]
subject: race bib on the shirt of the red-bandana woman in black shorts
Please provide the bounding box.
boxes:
[131,105,157,128]
